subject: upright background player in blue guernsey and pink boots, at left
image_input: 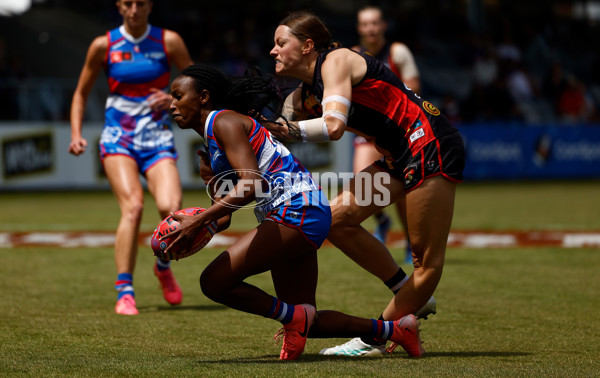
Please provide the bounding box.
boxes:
[69,0,192,315]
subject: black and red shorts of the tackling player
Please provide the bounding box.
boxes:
[375,131,465,193]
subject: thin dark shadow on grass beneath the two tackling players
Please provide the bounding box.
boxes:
[197,351,533,364]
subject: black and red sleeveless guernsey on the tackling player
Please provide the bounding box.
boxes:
[302,49,455,158]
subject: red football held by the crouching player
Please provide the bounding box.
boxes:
[150,207,217,260]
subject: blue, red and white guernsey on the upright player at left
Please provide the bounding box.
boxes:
[102,25,173,150]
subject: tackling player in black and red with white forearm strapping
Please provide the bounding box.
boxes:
[264,12,465,354]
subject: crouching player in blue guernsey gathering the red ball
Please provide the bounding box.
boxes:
[167,65,422,360]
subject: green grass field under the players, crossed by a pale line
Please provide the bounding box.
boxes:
[0,182,600,377]
